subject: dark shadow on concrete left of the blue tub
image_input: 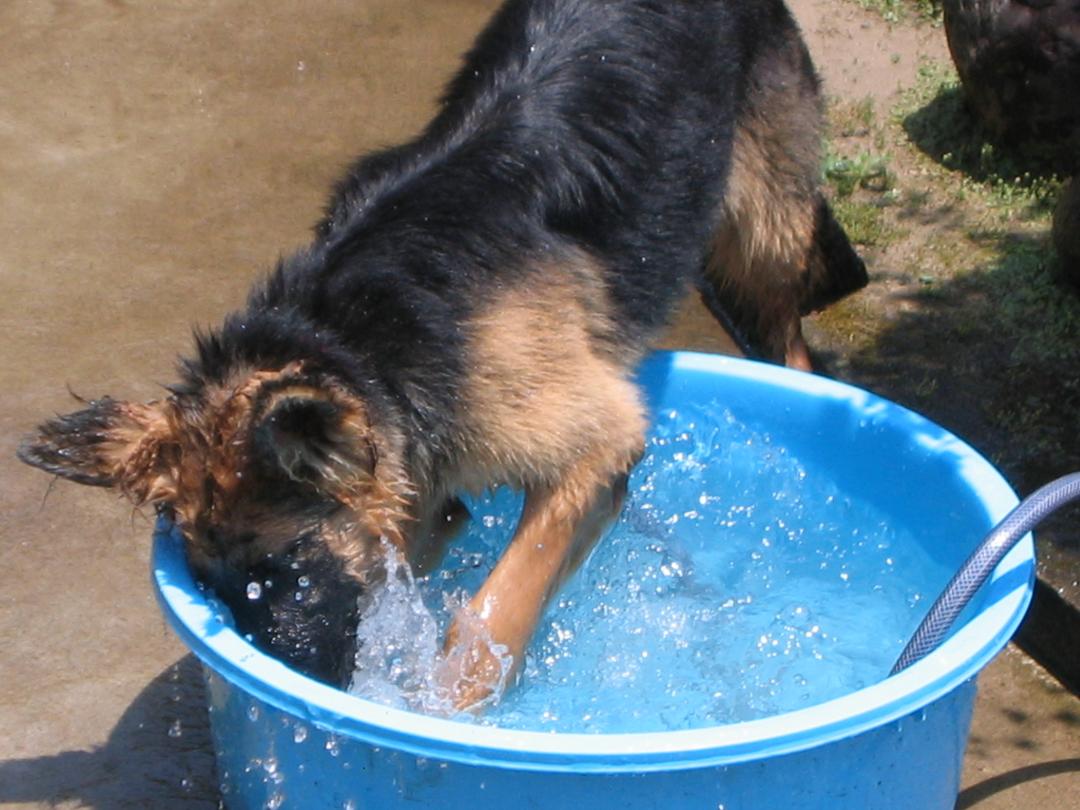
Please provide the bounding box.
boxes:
[0,656,218,810]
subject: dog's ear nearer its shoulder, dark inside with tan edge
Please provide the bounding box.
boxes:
[255,386,379,501]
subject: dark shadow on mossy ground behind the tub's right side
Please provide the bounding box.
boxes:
[843,219,1080,605]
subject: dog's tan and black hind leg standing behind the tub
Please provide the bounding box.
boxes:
[702,28,866,369]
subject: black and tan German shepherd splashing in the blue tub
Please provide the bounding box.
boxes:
[19,0,866,708]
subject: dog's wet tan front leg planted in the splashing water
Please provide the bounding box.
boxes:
[445,463,627,711]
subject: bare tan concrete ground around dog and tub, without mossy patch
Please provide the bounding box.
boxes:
[0,0,1080,810]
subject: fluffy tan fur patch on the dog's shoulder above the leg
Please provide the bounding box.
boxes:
[456,256,646,489]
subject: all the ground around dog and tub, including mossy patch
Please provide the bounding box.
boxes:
[0,0,1080,810]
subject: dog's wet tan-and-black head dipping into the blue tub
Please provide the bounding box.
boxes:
[19,363,409,685]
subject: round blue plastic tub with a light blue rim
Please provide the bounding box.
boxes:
[147,352,1034,810]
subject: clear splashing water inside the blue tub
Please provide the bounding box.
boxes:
[351,406,947,732]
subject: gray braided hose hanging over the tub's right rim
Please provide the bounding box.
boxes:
[889,473,1080,675]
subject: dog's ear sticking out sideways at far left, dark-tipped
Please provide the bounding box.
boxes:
[18,397,177,503]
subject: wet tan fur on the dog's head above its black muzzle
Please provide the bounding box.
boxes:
[91,363,413,579]
